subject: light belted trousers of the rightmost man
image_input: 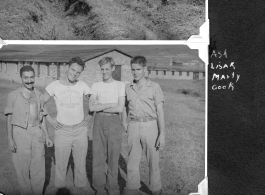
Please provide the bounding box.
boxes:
[126,120,162,191]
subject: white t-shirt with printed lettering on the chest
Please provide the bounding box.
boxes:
[46,80,90,125]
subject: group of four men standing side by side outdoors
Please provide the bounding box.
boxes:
[4,56,165,195]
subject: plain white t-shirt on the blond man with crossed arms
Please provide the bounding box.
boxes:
[90,81,125,104]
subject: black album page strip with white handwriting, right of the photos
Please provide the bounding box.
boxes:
[208,0,265,195]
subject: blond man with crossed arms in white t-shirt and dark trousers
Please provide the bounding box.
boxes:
[89,57,125,195]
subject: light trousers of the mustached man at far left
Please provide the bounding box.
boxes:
[13,126,45,195]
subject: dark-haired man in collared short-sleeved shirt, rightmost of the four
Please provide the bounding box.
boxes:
[122,56,165,195]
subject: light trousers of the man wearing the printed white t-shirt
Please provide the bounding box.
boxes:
[54,126,88,188]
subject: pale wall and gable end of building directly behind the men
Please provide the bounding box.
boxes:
[0,51,133,87]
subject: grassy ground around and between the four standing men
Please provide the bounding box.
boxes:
[0,81,205,195]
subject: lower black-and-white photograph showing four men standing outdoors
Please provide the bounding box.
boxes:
[0,44,207,195]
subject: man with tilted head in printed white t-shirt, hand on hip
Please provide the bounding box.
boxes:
[43,57,90,192]
